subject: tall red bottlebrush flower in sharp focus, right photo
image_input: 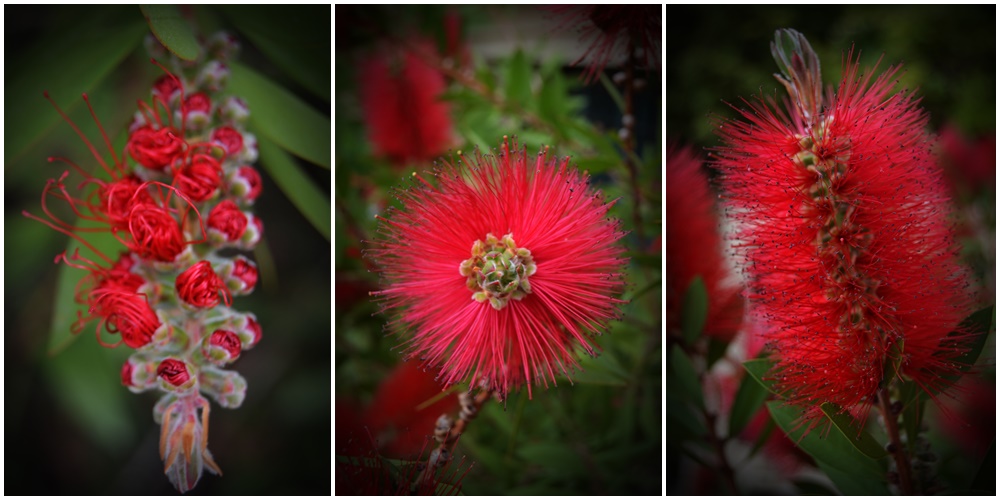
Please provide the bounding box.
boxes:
[716,30,969,423]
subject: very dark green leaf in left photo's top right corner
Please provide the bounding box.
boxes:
[219,5,330,102]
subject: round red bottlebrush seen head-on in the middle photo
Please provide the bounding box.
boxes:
[369,137,626,397]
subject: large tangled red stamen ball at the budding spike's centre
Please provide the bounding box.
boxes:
[124,203,187,262]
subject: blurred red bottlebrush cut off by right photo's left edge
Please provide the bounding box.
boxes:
[664,148,743,341]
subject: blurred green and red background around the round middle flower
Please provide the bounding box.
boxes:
[334,5,663,495]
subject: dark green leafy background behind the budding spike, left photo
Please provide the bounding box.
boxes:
[4,5,332,495]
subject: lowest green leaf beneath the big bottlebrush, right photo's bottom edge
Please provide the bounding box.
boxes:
[767,401,889,495]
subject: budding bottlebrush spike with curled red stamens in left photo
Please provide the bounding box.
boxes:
[25,33,263,492]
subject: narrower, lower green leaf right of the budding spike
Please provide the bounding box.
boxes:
[257,136,330,240]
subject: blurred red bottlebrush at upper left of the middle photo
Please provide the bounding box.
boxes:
[360,40,452,166]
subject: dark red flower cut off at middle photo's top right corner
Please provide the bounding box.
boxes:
[550,4,663,83]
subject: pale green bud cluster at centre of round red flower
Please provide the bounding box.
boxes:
[458,233,537,311]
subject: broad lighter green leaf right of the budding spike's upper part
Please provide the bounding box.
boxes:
[229,62,330,168]
